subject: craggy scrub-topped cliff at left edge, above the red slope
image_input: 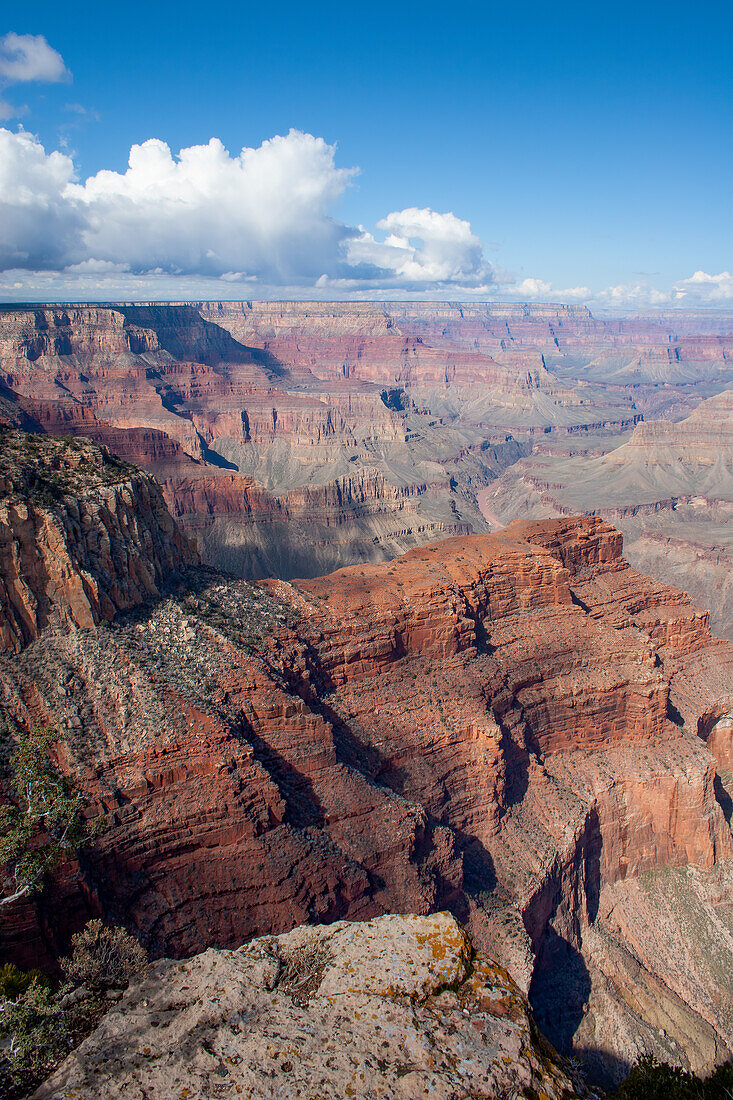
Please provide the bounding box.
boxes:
[0,428,198,652]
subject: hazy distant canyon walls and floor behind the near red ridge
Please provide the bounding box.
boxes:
[0,301,733,638]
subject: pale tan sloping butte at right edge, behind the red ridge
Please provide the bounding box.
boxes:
[481,388,733,638]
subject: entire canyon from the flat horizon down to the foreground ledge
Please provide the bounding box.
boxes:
[0,301,733,1096]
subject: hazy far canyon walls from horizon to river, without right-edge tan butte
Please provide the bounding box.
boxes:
[0,303,733,578]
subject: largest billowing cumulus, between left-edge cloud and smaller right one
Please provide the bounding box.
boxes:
[66,130,353,282]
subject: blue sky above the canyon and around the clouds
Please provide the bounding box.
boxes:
[0,0,733,306]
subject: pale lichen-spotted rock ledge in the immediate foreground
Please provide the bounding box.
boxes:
[35,913,577,1100]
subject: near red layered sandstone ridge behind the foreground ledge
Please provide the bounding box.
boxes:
[0,462,733,1077]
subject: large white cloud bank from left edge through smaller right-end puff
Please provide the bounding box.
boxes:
[0,129,493,289]
